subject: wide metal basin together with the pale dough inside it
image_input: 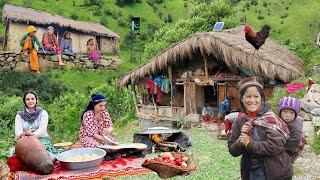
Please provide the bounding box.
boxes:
[57,148,106,169]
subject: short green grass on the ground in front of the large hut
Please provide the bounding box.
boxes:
[116,122,240,180]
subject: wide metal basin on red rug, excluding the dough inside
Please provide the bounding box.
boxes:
[57,148,106,169]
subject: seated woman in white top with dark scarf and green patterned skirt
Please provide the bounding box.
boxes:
[15,91,63,154]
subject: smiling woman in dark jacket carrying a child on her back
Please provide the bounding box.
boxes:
[228,77,293,180]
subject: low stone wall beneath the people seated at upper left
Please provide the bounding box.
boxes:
[0,52,121,72]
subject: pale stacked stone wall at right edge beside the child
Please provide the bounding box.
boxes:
[300,84,320,137]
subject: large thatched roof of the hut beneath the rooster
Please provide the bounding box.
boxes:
[118,27,305,87]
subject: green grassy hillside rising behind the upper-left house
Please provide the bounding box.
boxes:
[0,0,188,46]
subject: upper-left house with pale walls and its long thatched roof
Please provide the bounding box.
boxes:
[2,4,120,54]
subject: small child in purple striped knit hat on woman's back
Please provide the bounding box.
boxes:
[278,96,306,162]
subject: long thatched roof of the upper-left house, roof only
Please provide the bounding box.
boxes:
[2,4,119,38]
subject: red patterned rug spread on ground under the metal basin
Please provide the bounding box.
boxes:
[14,157,152,180]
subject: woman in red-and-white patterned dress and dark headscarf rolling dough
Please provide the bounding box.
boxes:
[79,93,117,147]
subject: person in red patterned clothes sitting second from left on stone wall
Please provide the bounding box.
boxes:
[42,26,65,66]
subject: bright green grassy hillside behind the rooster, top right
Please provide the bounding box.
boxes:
[236,0,320,44]
